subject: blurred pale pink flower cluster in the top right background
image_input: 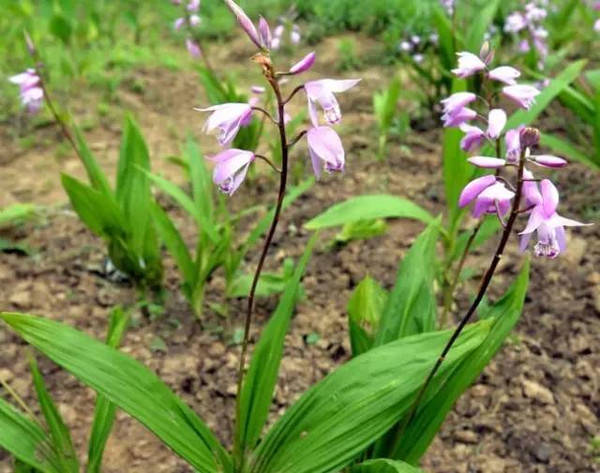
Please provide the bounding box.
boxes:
[504,0,548,70]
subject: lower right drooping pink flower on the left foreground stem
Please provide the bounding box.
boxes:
[306,126,345,179]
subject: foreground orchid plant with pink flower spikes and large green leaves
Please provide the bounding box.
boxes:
[0,5,582,473]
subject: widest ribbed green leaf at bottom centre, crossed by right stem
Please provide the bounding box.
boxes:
[250,321,490,473]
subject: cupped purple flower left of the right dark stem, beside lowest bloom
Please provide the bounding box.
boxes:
[458,176,515,218]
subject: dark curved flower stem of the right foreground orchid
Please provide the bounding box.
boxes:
[392,151,525,451]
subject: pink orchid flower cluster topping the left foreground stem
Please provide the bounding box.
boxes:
[197,0,359,195]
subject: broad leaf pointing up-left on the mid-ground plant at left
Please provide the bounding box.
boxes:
[61,174,128,238]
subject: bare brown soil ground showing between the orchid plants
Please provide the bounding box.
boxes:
[0,34,600,473]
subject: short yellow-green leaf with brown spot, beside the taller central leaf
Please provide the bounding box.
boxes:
[348,276,388,356]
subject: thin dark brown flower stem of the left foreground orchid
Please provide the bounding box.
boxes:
[235,76,289,471]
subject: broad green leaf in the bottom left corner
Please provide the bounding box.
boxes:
[0,397,64,473]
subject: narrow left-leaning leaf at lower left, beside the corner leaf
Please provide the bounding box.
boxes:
[29,357,79,473]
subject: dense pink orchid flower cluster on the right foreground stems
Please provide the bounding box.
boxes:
[442,46,584,258]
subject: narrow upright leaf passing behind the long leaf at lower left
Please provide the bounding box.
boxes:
[86,307,129,473]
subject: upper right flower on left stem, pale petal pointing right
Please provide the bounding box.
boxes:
[304,79,360,127]
